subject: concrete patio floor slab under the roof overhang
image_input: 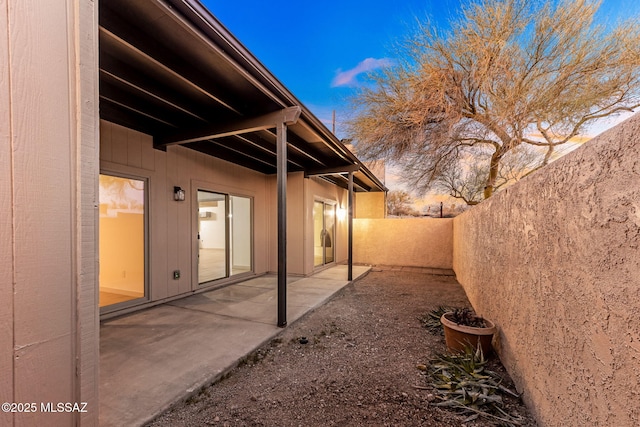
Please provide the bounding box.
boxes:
[100,265,370,426]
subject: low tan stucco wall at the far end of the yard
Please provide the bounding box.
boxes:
[353,218,453,269]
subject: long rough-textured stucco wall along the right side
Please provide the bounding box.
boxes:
[454,115,640,426]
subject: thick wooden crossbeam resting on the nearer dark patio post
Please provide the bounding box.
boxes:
[154,106,301,148]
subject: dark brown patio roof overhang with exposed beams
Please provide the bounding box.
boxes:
[99,0,386,191]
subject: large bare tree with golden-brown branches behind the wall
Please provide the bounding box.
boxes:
[350,0,640,200]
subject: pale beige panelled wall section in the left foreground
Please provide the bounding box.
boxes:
[0,0,99,426]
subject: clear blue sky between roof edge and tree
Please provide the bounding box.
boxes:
[201,0,640,137]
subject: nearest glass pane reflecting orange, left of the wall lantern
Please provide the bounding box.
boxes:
[99,174,147,311]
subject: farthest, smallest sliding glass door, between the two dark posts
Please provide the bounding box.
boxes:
[313,201,336,267]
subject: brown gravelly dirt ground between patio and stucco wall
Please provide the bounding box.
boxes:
[149,269,536,427]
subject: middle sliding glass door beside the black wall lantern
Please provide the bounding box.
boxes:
[197,190,252,284]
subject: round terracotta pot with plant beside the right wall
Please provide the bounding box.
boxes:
[440,308,496,356]
